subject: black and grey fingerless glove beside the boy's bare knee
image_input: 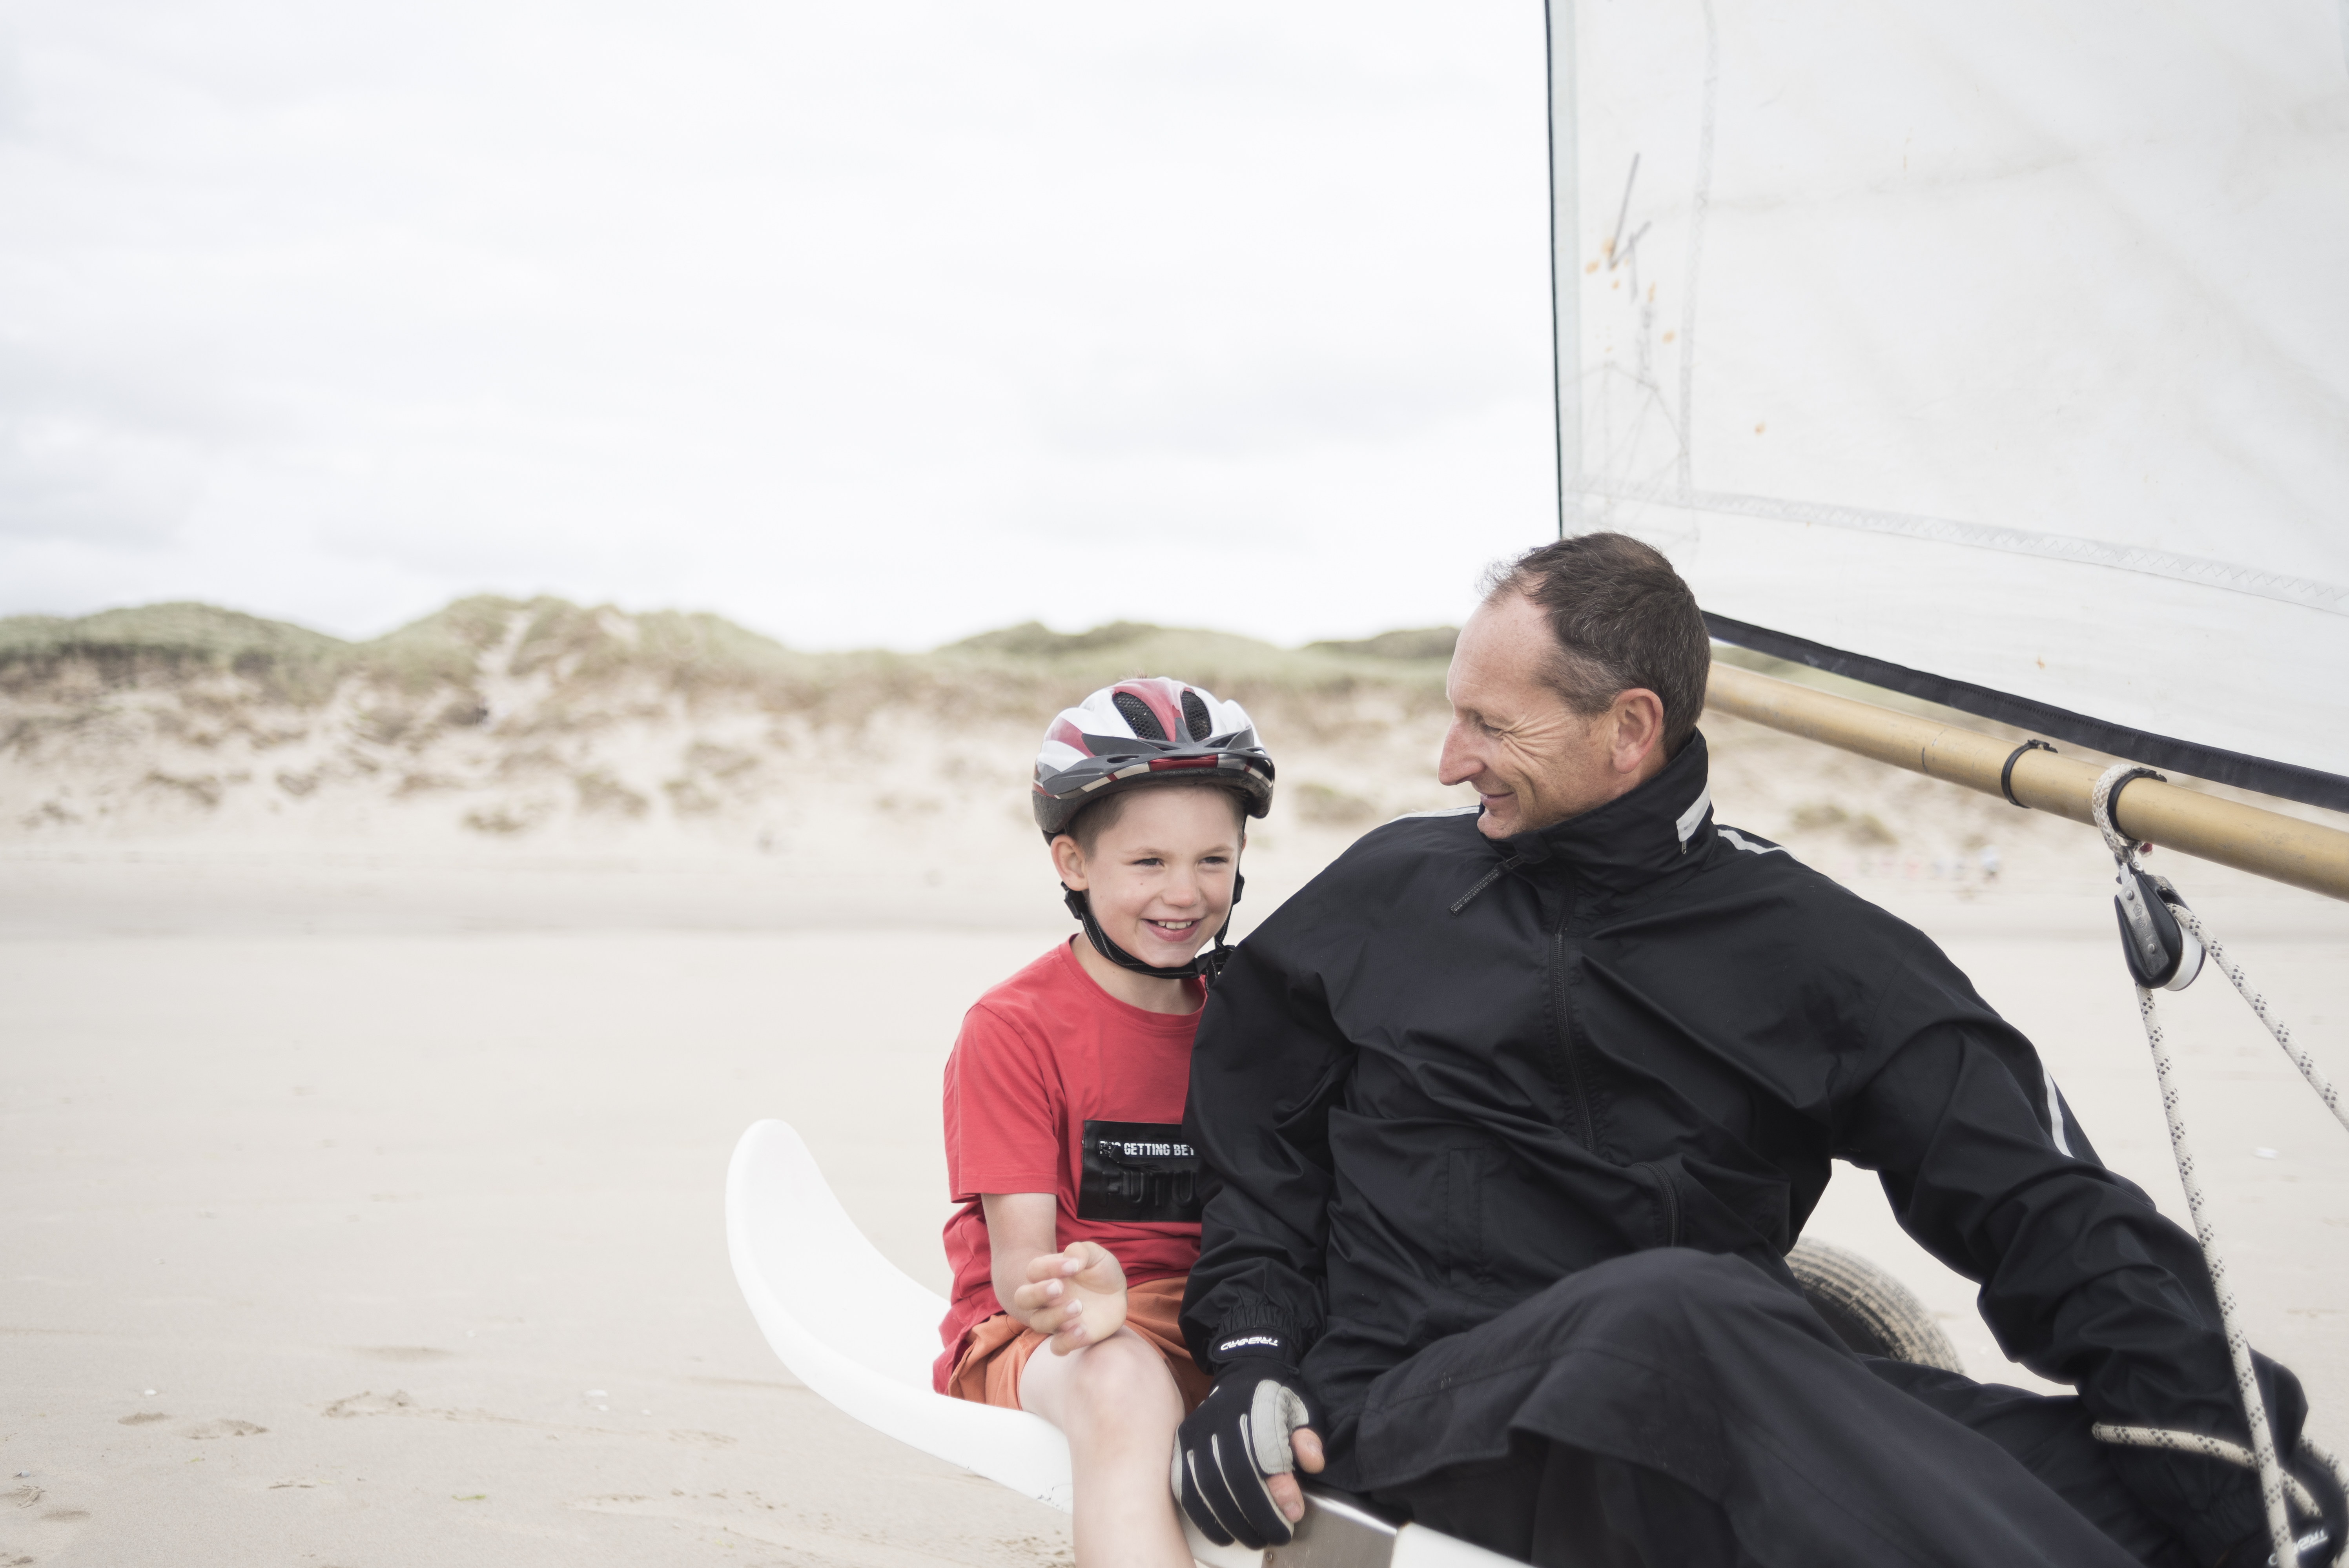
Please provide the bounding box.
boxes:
[1175,1336,1313,1552]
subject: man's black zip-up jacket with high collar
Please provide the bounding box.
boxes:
[1181,735,2304,1488]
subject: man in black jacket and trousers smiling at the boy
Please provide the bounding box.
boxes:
[1175,533,2342,1568]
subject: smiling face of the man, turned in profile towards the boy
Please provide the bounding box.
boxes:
[1438,594,1654,838]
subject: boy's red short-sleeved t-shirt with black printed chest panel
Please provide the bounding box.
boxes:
[933,941,1205,1392]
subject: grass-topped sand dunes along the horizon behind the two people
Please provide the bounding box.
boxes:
[0,599,2311,918]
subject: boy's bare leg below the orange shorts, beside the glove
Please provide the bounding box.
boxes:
[1019,1329,1191,1568]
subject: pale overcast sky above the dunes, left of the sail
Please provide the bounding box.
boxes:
[0,0,1555,648]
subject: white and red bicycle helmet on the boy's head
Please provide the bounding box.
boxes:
[1031,676,1273,838]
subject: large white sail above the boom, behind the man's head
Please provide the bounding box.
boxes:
[1550,0,2349,807]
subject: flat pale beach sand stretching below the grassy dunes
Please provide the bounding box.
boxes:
[0,798,2349,1568]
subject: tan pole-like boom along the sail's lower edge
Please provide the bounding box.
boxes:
[1706,664,2349,899]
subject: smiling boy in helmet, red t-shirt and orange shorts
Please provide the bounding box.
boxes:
[935,678,1273,1568]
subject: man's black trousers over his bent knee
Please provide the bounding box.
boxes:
[1353,1249,2192,1568]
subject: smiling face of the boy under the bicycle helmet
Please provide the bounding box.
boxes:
[1052,786,1243,967]
